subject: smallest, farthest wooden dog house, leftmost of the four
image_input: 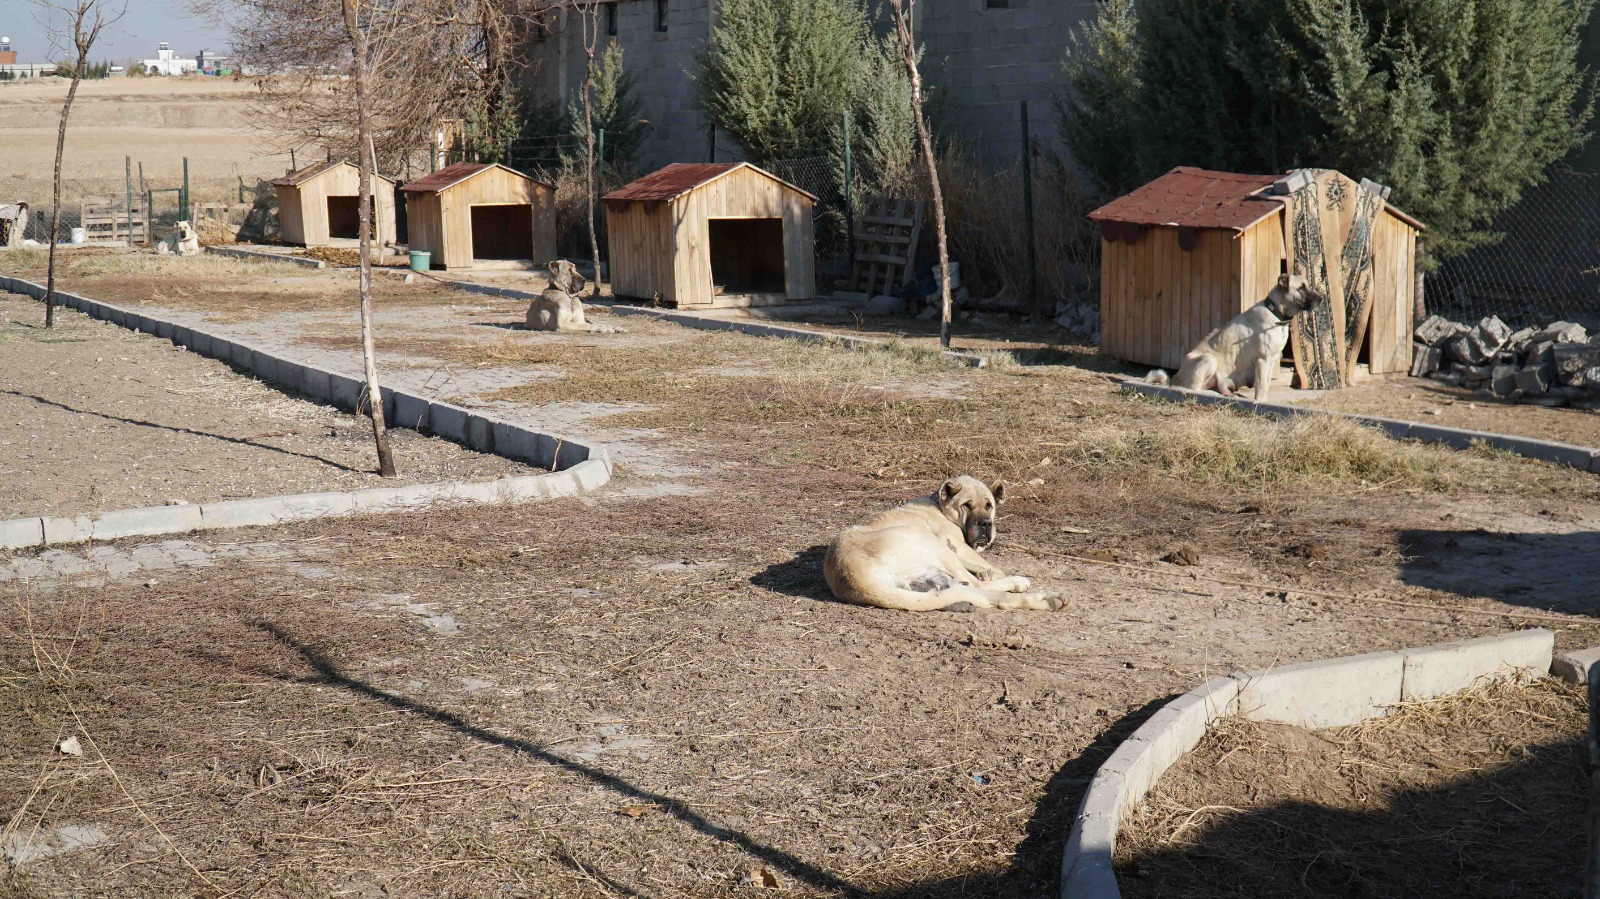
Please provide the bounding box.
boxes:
[272,162,395,246]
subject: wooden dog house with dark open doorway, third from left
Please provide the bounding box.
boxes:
[605,163,816,309]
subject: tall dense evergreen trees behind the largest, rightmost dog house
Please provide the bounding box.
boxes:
[1059,0,1594,261]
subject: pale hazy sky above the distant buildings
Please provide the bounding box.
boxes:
[0,0,227,62]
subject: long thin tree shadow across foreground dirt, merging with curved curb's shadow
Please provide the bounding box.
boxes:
[254,621,1170,899]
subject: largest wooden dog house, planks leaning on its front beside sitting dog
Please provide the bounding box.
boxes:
[1090,168,1422,389]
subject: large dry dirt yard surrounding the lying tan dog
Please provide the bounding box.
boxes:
[9,259,1600,899]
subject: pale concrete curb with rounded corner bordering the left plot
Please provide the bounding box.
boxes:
[0,275,611,550]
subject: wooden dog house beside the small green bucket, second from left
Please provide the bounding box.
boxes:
[400,162,555,269]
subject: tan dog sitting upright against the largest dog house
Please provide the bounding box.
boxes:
[1146,275,1326,402]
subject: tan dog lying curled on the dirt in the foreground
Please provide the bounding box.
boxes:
[822,475,1061,611]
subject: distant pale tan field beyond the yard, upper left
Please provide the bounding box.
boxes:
[0,77,290,206]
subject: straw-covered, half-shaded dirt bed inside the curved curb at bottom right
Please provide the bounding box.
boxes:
[1117,678,1589,899]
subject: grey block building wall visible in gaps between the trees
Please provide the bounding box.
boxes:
[525,0,1096,171]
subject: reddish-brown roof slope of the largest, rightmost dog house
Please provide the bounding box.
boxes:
[1090,166,1282,230]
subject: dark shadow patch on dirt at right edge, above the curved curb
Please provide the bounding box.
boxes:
[1397,529,1600,614]
